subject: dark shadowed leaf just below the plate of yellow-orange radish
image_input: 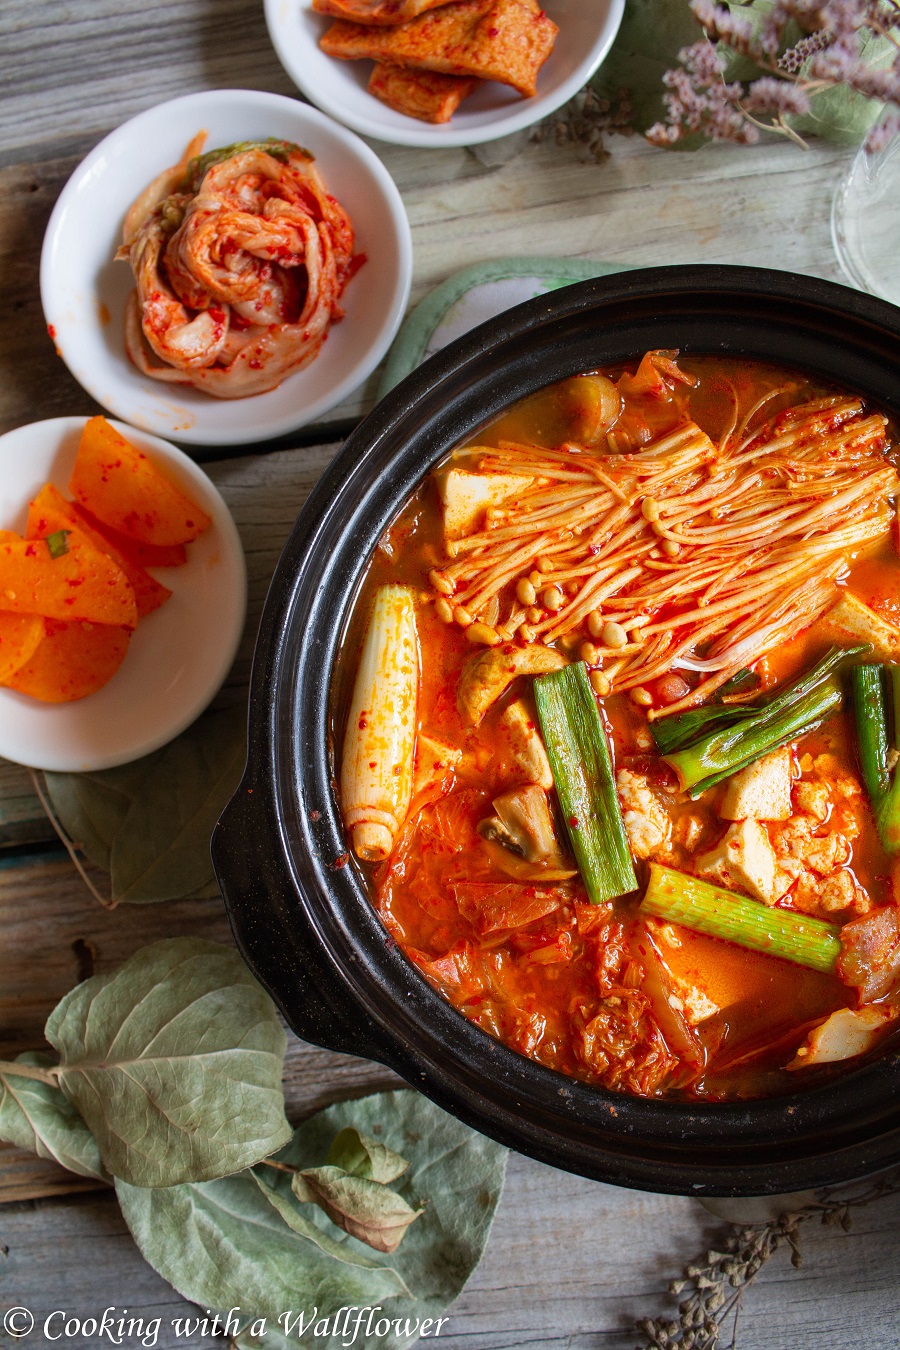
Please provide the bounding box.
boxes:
[45,706,247,905]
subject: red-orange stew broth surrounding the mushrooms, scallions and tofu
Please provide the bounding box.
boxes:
[336,358,900,1099]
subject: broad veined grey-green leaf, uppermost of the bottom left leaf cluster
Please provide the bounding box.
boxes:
[46,938,290,1187]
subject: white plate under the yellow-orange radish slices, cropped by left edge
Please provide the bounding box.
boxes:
[0,417,247,772]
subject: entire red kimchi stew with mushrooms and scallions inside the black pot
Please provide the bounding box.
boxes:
[336,351,900,1100]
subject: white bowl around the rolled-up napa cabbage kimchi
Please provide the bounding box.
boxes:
[40,89,413,446]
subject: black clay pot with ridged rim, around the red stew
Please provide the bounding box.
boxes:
[212,267,900,1196]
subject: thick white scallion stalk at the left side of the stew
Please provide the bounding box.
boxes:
[340,586,418,863]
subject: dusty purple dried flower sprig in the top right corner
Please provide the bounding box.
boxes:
[648,0,900,150]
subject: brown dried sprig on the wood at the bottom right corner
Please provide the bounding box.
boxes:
[637,1170,900,1350]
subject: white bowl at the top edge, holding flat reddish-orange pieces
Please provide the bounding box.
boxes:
[264,0,625,146]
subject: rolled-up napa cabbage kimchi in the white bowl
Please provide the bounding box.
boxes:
[116,134,359,398]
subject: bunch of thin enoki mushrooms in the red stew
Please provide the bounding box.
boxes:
[430,397,900,716]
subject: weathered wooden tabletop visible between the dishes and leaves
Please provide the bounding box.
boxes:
[0,0,900,1350]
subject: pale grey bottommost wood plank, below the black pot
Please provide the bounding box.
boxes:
[3,1156,900,1350]
